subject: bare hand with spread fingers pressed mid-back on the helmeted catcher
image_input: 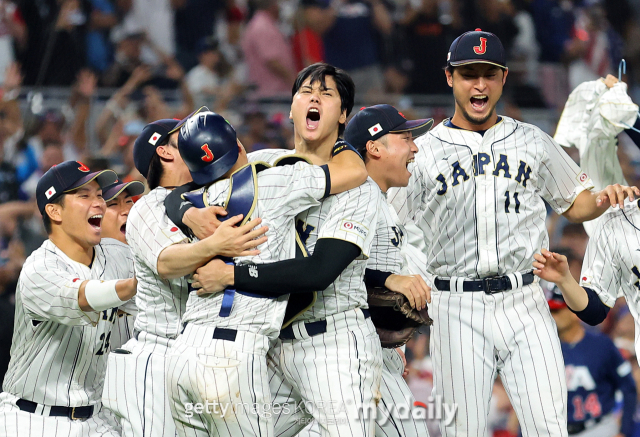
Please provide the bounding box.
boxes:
[203,214,269,258]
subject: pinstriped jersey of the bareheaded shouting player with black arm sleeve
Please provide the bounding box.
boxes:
[248,150,380,320]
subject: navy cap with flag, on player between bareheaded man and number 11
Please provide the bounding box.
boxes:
[344,105,433,154]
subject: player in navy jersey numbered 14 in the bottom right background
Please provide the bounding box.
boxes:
[547,286,637,437]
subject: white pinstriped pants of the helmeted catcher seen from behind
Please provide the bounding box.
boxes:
[166,324,273,437]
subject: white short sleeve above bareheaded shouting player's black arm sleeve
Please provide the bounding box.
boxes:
[318,180,379,258]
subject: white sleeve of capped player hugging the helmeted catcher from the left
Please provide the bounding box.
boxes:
[127,197,188,276]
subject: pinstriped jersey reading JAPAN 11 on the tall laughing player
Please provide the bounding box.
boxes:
[389,117,593,278]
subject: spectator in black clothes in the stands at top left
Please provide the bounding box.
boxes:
[20,0,91,86]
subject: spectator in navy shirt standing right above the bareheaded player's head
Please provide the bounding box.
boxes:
[307,0,393,95]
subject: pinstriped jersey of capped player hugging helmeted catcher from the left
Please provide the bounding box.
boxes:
[127,187,188,338]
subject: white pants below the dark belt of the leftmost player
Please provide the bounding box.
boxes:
[0,392,120,437]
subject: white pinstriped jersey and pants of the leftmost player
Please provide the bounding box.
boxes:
[0,239,133,437]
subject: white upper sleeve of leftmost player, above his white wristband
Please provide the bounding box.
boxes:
[18,257,100,326]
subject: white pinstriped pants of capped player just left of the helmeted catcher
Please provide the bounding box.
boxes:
[102,332,176,437]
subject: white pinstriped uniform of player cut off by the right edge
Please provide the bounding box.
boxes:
[580,201,640,360]
